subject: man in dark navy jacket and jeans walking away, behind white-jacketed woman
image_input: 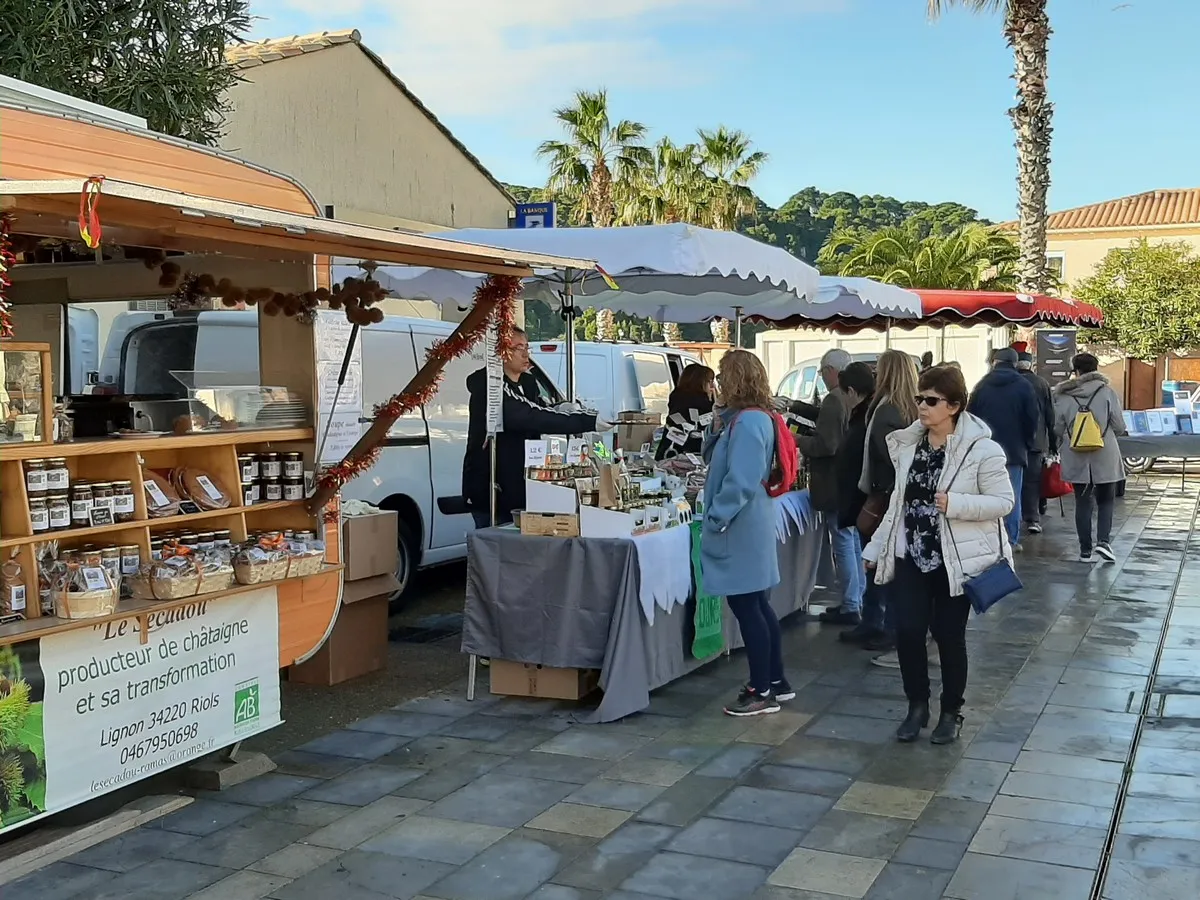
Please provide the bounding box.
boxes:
[967,347,1038,550]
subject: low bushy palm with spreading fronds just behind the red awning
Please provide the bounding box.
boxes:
[817,224,1018,290]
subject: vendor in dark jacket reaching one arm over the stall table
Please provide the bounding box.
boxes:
[462,329,612,528]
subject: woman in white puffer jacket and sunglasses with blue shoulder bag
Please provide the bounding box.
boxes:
[863,366,1014,744]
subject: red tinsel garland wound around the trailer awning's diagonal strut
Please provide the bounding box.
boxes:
[317,275,521,521]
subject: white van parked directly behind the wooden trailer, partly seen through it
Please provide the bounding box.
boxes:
[108,310,562,598]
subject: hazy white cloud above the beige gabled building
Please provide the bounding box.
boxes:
[252,0,847,119]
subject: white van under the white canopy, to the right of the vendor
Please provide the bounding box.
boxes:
[529,341,702,422]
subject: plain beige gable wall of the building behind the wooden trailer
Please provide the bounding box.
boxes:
[221,43,511,230]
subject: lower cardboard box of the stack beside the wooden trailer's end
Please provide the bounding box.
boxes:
[288,572,400,686]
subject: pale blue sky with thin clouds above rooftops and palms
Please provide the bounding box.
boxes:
[251,0,1200,220]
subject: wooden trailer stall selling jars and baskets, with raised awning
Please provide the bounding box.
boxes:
[0,102,589,832]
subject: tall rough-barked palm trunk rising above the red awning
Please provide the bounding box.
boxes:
[928,0,1054,294]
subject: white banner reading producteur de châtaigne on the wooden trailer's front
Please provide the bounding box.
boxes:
[0,588,280,832]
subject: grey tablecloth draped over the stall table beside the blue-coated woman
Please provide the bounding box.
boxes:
[462,527,823,722]
